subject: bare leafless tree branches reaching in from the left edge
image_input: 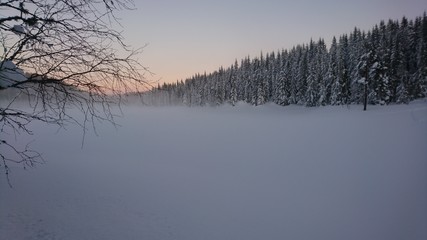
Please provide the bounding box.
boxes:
[0,0,150,181]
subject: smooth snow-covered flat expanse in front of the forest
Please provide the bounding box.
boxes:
[0,100,427,240]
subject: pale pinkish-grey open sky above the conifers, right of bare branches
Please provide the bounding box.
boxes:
[119,0,427,83]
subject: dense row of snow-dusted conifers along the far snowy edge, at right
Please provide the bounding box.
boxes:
[143,13,427,107]
